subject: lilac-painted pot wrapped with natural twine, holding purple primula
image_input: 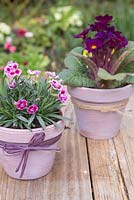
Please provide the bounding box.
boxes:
[68,85,132,139]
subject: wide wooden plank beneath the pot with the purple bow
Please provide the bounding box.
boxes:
[0,102,92,200]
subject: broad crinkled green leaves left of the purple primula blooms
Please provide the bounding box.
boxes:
[59,47,96,87]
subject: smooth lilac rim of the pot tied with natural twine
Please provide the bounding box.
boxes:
[68,84,133,103]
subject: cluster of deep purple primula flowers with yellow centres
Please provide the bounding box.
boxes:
[75,14,128,72]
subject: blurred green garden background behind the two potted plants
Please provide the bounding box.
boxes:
[0,0,134,72]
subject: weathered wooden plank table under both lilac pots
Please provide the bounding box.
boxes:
[0,96,134,200]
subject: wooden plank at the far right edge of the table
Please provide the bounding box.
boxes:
[114,96,134,200]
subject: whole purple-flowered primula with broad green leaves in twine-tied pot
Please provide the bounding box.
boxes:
[60,15,134,88]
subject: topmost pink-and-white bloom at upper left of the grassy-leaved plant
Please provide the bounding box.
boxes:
[4,61,22,79]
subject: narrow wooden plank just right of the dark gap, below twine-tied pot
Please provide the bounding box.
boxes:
[87,139,128,200]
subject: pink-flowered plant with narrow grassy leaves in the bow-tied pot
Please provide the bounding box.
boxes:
[0,61,67,130]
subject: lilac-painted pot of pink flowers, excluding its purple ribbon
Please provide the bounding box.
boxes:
[0,121,64,180]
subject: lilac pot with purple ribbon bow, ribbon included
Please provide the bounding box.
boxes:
[0,121,64,180]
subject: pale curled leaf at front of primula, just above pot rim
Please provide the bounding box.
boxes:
[98,68,127,81]
